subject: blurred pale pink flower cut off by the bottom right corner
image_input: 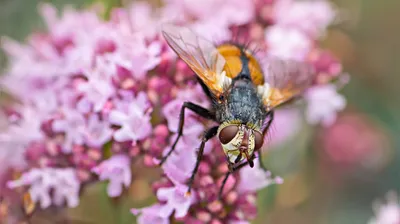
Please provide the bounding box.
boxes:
[368,192,400,224]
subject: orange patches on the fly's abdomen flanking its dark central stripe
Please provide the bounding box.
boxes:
[217,44,264,85]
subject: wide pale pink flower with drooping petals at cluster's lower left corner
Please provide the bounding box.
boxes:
[7,168,80,209]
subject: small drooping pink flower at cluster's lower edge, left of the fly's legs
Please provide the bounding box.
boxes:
[92,155,132,197]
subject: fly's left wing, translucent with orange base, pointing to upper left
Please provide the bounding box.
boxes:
[162,25,231,97]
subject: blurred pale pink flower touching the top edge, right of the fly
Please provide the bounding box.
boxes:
[274,0,336,37]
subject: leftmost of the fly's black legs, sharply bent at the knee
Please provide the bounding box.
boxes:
[160,102,215,165]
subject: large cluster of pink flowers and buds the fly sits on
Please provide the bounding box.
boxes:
[0,0,345,223]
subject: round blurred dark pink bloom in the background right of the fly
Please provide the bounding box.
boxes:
[321,112,389,169]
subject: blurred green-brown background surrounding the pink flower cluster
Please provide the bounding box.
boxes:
[0,0,400,224]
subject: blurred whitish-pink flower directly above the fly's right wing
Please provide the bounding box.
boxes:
[265,25,312,60]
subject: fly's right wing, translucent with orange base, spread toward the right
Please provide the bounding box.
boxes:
[258,58,316,109]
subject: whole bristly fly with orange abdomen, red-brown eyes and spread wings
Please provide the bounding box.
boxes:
[161,25,314,196]
